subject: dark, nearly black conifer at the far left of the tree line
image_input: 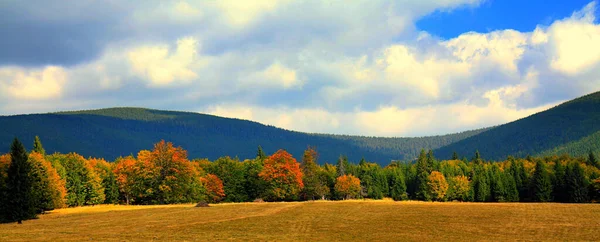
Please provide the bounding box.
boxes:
[4,138,37,224]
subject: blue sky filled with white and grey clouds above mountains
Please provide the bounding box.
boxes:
[0,0,600,136]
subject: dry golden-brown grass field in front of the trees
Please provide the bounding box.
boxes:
[0,200,600,241]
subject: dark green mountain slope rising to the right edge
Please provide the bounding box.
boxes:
[434,92,600,160]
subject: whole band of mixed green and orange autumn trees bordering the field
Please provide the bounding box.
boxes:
[0,136,600,223]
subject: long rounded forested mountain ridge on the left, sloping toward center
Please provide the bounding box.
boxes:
[0,108,485,165]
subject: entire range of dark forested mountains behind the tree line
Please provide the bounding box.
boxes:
[0,92,600,165]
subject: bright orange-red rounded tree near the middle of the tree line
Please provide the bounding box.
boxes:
[259,150,304,200]
